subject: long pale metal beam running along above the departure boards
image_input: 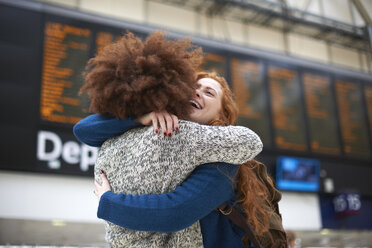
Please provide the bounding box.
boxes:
[0,0,371,81]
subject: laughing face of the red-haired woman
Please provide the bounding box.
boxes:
[190,78,223,125]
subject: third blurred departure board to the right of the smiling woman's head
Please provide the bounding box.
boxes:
[302,73,341,155]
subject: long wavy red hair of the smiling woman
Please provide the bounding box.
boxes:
[196,72,281,247]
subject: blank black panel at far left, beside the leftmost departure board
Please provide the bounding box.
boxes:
[0,4,44,171]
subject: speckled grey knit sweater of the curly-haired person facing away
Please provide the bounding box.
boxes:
[95,121,263,248]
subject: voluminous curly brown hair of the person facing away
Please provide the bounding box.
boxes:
[80,31,203,119]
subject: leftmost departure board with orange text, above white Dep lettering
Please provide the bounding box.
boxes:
[40,21,92,124]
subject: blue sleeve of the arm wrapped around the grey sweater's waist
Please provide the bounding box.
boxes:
[97,163,237,232]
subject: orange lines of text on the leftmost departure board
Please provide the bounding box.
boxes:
[40,22,91,124]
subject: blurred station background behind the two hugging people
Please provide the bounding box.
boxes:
[0,0,372,247]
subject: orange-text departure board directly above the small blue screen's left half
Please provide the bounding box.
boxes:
[268,65,307,151]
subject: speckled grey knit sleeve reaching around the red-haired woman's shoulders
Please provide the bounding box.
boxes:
[180,121,263,164]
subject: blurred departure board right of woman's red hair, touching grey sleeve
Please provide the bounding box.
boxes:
[230,59,271,146]
